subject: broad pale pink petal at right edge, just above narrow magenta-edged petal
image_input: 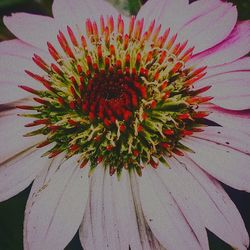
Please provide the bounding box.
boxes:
[198,71,250,110]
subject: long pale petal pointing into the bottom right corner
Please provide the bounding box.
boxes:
[157,158,248,249]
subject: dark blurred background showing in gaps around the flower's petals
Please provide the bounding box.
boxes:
[0,0,250,250]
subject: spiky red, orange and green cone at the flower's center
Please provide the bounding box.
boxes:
[20,16,211,177]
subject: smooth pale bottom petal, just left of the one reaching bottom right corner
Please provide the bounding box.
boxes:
[138,167,202,250]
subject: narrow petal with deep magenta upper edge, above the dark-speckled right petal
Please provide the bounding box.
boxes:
[206,105,250,134]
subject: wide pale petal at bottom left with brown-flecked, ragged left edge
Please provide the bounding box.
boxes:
[24,157,89,250]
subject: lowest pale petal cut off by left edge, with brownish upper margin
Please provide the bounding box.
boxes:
[0,147,50,201]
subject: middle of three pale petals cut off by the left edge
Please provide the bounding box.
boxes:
[0,109,44,162]
